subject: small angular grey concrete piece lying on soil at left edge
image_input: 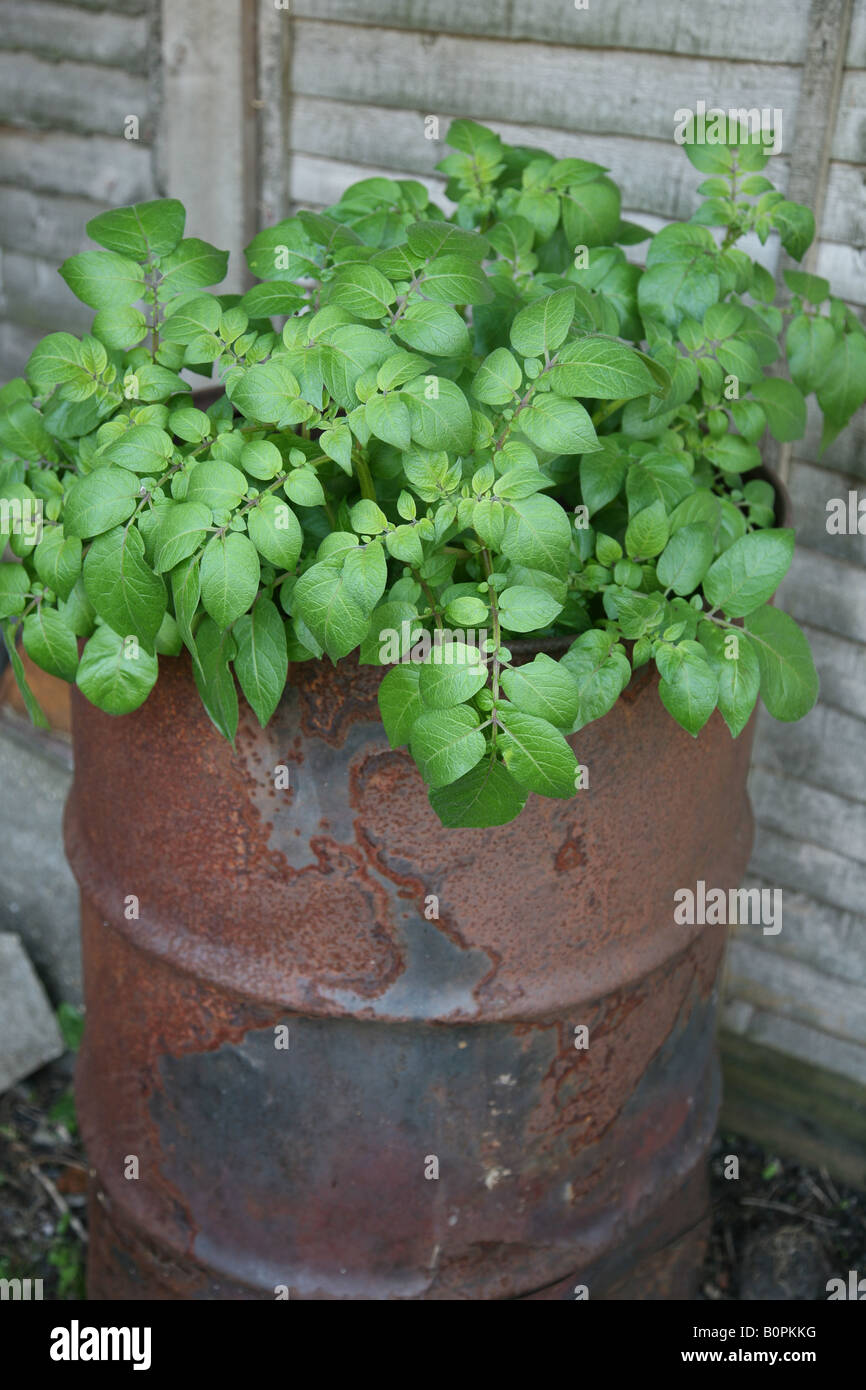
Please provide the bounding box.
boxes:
[0,931,64,1091]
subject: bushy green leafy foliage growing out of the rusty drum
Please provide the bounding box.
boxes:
[0,121,866,826]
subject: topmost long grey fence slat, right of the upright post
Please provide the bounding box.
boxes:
[292,0,808,63]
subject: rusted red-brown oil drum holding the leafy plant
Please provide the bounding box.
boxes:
[67,644,752,1300]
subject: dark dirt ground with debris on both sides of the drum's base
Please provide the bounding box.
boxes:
[0,1050,866,1301]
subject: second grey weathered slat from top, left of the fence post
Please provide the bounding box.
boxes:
[0,53,150,142]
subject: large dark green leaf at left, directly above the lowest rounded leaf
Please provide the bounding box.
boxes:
[83,527,167,651]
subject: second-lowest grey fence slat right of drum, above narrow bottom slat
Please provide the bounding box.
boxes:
[726,934,866,1047]
